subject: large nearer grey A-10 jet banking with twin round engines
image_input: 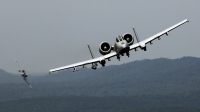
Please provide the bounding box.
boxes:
[49,19,189,73]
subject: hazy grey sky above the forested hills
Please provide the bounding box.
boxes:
[0,0,200,74]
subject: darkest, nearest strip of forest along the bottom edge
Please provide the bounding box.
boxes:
[0,95,200,112]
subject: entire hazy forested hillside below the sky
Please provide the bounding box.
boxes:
[0,57,200,112]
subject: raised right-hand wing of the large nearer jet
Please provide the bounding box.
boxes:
[130,19,189,50]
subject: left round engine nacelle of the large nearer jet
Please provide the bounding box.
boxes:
[99,42,112,55]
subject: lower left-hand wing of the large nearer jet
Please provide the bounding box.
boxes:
[49,52,117,73]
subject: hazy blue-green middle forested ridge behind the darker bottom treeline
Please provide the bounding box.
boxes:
[0,57,200,101]
